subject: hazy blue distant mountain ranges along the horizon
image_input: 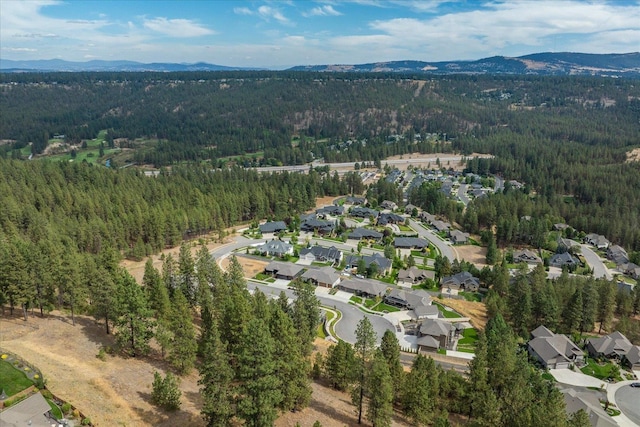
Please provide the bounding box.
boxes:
[0,52,640,78]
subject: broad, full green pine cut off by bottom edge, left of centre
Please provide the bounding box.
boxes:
[237,318,282,427]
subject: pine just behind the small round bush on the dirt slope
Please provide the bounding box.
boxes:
[169,292,198,374]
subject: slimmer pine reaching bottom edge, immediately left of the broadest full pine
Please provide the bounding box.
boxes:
[198,321,234,427]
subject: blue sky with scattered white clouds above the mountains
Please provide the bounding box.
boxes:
[0,0,640,69]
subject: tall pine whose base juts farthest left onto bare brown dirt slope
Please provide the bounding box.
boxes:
[115,269,153,357]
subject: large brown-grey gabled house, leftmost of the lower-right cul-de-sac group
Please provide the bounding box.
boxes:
[527,326,584,369]
